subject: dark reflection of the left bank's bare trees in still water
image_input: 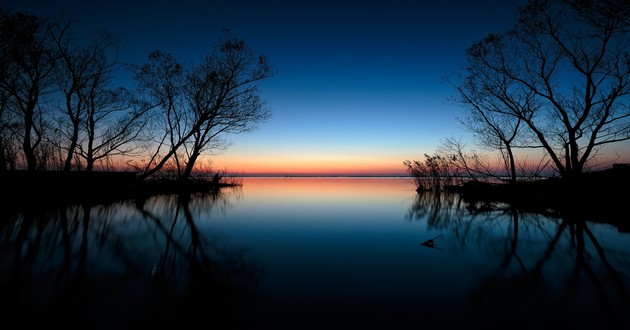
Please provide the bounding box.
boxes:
[0,187,260,328]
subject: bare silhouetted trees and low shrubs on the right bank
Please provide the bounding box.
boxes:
[403,0,630,187]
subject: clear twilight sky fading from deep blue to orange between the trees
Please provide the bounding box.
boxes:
[4,0,552,175]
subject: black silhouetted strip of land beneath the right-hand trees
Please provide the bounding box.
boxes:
[436,164,630,232]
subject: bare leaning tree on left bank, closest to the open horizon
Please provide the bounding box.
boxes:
[132,33,272,180]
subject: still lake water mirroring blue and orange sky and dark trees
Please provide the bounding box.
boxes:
[0,178,630,329]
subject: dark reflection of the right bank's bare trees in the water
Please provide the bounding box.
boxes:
[408,194,630,328]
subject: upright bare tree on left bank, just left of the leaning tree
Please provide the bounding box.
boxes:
[55,24,148,171]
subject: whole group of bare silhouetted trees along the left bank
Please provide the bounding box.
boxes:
[0,9,273,180]
